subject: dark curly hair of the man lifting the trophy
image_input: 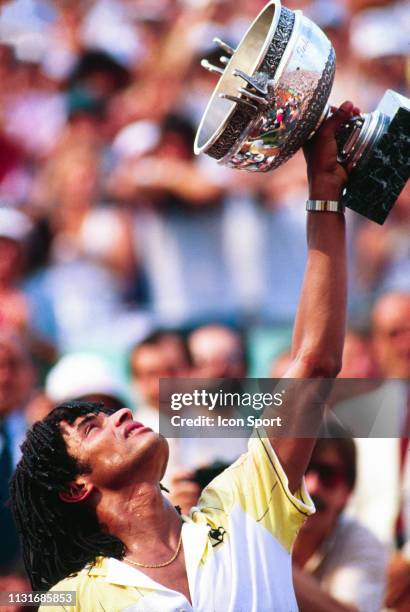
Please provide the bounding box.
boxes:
[10,401,125,590]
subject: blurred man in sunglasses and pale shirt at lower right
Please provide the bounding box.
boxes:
[293,422,387,612]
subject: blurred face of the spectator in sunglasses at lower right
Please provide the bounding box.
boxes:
[305,446,351,529]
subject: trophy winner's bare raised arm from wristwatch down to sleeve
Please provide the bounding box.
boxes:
[264,212,346,493]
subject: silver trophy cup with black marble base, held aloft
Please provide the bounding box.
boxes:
[194,0,410,224]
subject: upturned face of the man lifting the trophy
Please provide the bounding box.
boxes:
[61,408,168,492]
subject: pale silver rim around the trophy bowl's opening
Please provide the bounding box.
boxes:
[194,0,282,155]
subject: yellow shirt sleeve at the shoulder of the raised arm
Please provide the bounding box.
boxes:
[198,429,315,551]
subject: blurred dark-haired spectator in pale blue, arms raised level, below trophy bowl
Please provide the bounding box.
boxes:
[112,115,242,327]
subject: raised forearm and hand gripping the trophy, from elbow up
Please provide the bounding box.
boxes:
[292,102,358,378]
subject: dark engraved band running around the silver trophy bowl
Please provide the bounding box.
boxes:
[207,7,295,159]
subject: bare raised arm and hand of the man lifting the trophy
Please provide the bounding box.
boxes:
[266,102,359,492]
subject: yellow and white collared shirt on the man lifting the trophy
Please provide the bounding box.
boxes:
[40,430,314,612]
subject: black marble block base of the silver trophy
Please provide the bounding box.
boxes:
[342,91,410,225]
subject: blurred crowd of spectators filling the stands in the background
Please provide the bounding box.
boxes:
[0,0,410,612]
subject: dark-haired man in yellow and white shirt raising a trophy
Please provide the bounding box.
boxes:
[11,102,358,612]
